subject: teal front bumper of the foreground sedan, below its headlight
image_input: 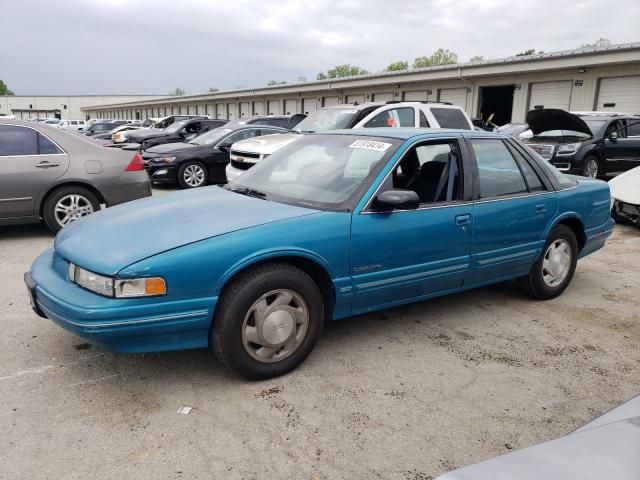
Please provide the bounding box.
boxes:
[24,249,217,353]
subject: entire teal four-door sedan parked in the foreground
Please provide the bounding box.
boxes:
[25,128,614,379]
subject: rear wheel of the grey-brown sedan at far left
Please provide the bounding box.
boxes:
[42,186,100,233]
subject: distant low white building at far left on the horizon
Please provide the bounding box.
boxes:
[0,95,168,120]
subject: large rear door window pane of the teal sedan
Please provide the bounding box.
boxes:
[471,139,527,198]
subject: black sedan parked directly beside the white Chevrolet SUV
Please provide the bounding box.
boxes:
[142,124,288,188]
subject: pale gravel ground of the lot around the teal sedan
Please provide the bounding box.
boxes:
[0,190,640,480]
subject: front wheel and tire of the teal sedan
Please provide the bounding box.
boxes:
[211,263,324,380]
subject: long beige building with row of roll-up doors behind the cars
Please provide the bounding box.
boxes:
[82,43,640,124]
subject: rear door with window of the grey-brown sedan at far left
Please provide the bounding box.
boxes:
[0,125,69,218]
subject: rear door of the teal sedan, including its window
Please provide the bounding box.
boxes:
[468,138,558,285]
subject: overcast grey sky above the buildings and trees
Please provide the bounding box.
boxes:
[0,0,640,95]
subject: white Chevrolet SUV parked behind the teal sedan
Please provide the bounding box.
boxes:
[225,102,473,182]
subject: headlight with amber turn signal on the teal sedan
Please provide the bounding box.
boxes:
[69,263,167,298]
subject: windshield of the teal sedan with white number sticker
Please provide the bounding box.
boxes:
[225,135,401,210]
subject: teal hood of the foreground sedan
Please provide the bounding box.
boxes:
[54,186,319,275]
